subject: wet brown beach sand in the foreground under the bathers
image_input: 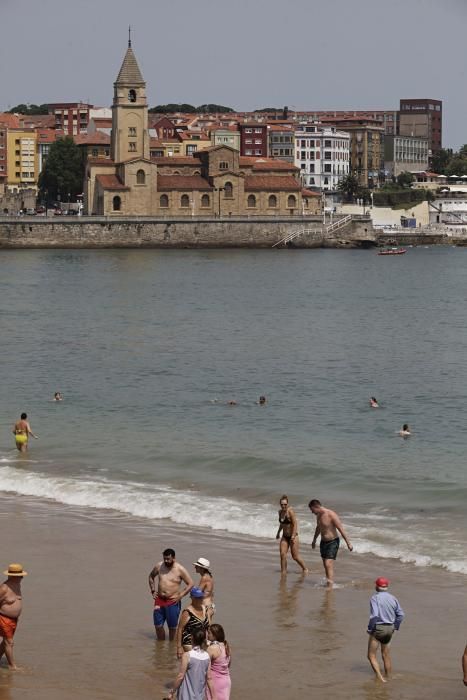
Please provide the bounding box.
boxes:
[0,496,467,700]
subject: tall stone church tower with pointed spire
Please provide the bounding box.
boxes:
[111,35,149,163]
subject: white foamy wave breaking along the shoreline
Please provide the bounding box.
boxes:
[0,466,467,574]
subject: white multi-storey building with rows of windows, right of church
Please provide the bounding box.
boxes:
[295,123,350,192]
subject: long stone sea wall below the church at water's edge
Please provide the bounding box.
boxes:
[0,216,376,248]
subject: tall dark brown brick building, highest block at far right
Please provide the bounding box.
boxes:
[399,99,443,157]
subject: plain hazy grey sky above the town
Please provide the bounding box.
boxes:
[0,0,467,148]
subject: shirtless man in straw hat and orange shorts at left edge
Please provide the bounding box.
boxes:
[0,564,27,671]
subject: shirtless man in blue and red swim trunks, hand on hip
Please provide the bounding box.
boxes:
[149,549,193,640]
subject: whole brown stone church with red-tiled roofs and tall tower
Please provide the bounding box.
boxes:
[84,39,320,218]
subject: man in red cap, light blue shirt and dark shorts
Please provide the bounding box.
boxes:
[368,576,404,683]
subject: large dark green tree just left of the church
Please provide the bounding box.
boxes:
[39,136,84,202]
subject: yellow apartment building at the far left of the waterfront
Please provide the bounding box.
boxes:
[6,129,39,192]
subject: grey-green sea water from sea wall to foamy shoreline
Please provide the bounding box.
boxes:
[0,248,467,574]
